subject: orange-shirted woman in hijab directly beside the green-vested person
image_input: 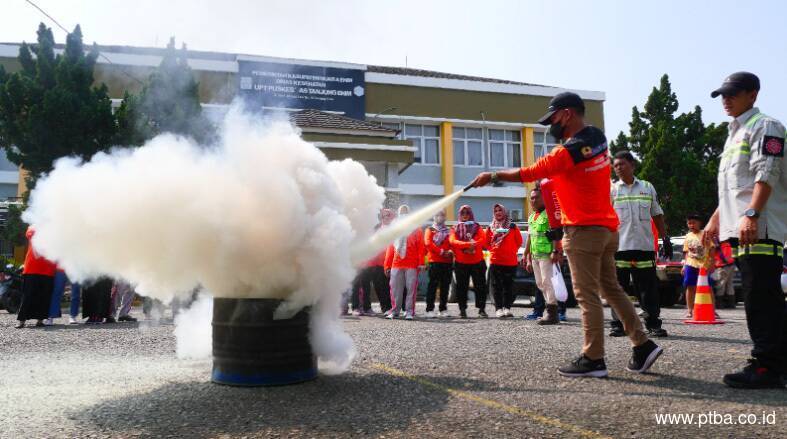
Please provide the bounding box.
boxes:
[486,204,522,318]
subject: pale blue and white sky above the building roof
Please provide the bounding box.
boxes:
[0,0,787,137]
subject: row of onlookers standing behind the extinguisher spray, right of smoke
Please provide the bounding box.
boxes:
[343,191,566,325]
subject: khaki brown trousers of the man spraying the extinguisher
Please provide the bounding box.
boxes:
[563,226,648,360]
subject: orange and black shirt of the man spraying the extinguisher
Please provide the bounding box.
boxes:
[519,126,620,232]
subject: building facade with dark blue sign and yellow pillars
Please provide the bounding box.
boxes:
[0,44,605,222]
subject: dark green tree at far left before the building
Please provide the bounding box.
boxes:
[0,23,117,189]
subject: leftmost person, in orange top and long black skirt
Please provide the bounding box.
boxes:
[16,226,57,328]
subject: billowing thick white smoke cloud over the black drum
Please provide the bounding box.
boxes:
[24,107,384,370]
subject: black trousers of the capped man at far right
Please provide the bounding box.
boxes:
[737,249,787,373]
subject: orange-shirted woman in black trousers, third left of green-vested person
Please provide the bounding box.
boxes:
[424,211,454,319]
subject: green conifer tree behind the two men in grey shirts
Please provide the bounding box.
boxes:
[610,75,727,233]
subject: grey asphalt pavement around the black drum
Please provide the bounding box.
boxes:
[0,303,787,438]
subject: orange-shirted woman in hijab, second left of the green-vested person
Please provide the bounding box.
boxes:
[448,205,489,319]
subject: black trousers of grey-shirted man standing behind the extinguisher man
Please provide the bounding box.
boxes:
[612,250,661,329]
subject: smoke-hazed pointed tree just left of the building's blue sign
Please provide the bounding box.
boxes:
[116,38,215,145]
